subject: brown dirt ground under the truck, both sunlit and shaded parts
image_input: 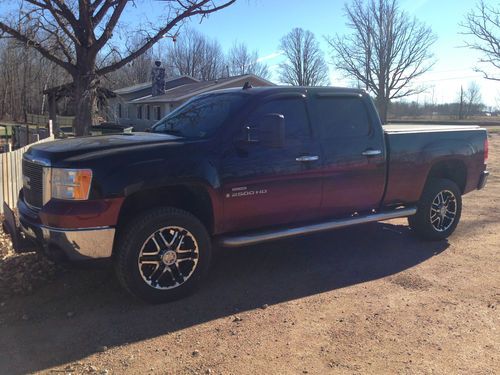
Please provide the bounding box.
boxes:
[0,135,500,374]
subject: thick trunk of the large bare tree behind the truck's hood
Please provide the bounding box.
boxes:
[73,72,97,137]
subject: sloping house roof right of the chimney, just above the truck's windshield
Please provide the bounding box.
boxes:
[129,74,274,104]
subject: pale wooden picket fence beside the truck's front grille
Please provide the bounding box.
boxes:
[0,136,54,214]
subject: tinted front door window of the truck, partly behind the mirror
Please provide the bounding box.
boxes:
[251,98,311,140]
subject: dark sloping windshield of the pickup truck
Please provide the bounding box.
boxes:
[151,93,244,138]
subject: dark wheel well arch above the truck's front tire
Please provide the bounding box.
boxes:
[118,185,214,233]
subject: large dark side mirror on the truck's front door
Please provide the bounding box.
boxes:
[243,113,285,148]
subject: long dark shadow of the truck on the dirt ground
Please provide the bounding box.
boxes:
[0,223,448,374]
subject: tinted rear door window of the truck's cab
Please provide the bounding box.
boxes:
[316,96,370,138]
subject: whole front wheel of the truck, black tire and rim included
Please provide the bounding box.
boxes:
[114,207,212,303]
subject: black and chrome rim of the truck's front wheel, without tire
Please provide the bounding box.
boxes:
[138,226,199,290]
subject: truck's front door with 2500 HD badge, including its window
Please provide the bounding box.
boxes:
[221,93,322,232]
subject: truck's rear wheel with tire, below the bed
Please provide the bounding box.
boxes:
[408,178,462,241]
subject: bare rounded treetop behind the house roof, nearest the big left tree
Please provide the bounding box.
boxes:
[167,28,224,80]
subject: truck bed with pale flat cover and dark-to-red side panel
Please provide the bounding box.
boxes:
[383,124,486,206]
